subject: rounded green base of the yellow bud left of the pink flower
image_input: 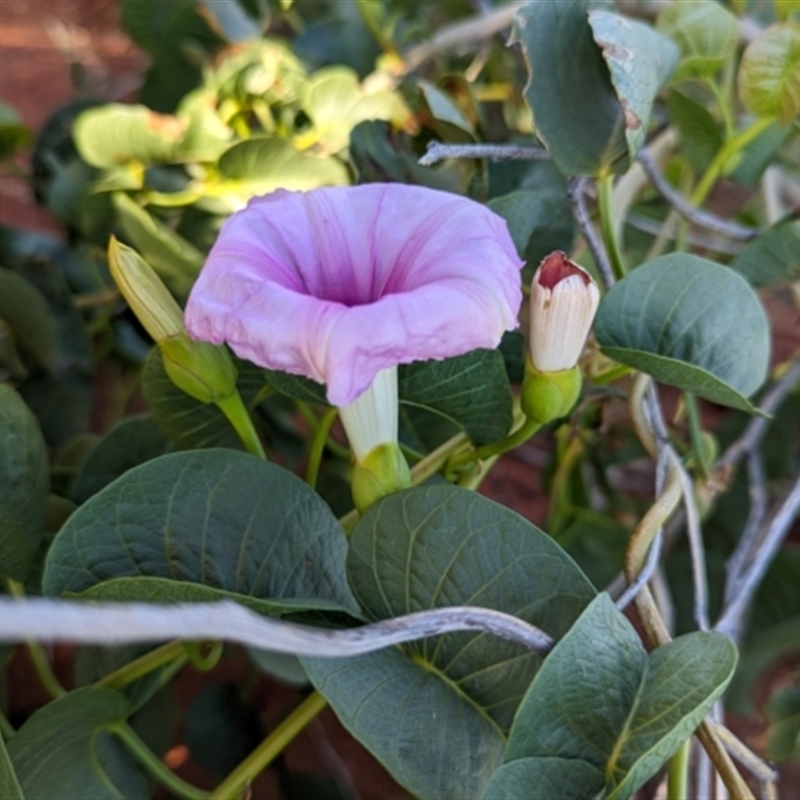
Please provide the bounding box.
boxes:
[159,333,238,403]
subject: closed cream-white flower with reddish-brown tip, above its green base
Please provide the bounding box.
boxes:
[530,251,600,372]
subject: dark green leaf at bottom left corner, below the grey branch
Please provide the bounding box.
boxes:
[8,687,149,800]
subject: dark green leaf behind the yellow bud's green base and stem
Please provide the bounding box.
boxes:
[142,347,264,450]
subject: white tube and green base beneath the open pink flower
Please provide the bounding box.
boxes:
[339,366,411,513]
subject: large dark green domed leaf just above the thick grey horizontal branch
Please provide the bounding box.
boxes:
[43,449,356,611]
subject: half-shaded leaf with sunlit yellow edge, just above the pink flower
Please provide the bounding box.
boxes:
[213,136,349,205]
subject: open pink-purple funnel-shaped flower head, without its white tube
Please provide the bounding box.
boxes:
[186,184,522,407]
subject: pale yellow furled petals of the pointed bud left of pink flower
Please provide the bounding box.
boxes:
[108,236,185,342]
